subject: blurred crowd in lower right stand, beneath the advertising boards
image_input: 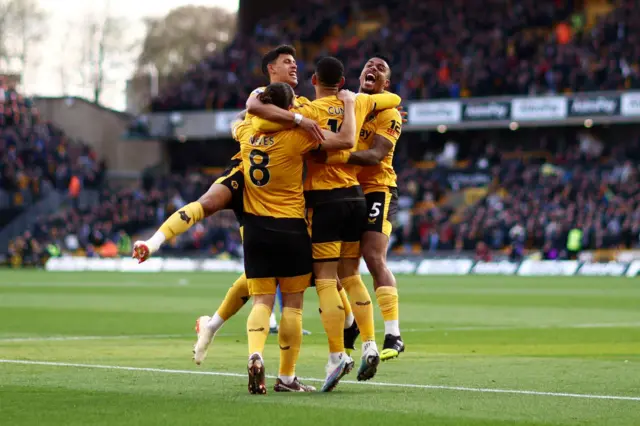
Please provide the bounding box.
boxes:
[395,132,640,259]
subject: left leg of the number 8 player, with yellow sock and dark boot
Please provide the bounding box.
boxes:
[247,278,276,394]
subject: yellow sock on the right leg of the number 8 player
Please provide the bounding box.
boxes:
[278,307,302,377]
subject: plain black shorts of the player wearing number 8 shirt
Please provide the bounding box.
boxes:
[243,214,313,279]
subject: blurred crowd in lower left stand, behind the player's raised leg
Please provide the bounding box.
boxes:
[7,174,242,265]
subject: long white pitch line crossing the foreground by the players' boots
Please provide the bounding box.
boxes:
[0,359,640,402]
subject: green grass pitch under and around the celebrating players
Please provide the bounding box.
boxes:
[0,270,640,426]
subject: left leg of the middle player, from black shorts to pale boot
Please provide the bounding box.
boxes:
[308,203,353,392]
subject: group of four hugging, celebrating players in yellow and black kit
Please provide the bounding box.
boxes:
[133,45,404,394]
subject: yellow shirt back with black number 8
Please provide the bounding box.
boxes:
[236,121,317,219]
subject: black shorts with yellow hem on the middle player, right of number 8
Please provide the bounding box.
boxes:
[307,199,367,262]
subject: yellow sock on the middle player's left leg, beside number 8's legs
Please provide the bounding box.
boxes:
[316,279,344,353]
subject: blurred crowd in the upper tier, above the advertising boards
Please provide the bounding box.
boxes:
[152,0,640,111]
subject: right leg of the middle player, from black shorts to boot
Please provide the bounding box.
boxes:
[339,200,380,380]
